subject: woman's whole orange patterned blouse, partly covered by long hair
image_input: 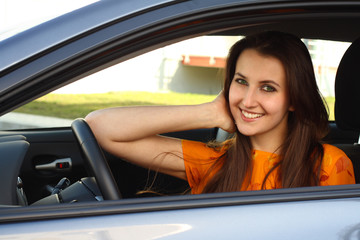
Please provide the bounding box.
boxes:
[182,140,355,194]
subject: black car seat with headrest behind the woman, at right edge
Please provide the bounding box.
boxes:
[334,38,360,183]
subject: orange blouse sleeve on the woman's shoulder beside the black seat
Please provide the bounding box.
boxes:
[320,144,355,186]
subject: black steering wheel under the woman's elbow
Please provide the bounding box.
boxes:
[71,118,121,200]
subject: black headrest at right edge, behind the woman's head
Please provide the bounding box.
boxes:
[335,38,360,131]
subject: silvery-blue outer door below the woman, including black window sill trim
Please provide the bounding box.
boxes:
[0,185,360,239]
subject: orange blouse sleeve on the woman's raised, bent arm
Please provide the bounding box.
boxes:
[182,140,224,194]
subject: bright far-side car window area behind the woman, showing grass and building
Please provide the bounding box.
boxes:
[0,36,349,130]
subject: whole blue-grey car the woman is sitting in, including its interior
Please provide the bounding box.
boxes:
[0,0,360,239]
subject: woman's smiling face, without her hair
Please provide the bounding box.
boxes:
[229,49,293,147]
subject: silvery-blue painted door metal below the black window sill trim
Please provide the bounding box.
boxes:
[0,198,360,240]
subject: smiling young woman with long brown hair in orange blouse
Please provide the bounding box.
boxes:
[86,32,355,194]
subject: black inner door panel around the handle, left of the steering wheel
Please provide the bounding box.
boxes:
[0,128,87,204]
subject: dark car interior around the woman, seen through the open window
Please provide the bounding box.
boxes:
[0,13,360,206]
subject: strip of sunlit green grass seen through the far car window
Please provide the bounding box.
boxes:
[16,92,335,120]
